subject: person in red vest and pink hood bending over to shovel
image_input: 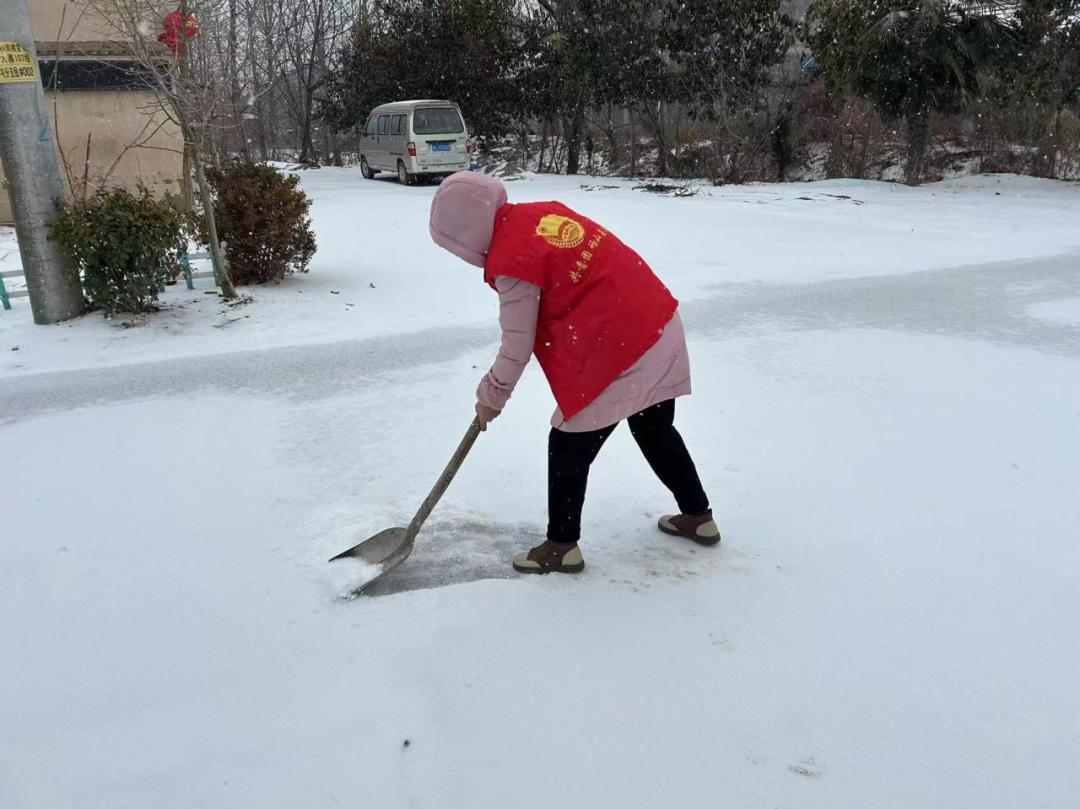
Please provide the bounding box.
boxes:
[430,172,720,574]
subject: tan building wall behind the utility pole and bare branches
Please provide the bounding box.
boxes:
[0,0,183,223]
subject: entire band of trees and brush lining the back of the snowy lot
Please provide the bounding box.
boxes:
[82,0,1080,183]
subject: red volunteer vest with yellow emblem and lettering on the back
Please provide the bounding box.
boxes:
[484,202,678,419]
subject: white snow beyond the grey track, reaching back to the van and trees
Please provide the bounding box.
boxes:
[0,168,1080,378]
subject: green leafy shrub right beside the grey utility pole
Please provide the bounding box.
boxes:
[49,188,189,316]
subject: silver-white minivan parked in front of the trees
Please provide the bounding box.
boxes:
[360,100,472,186]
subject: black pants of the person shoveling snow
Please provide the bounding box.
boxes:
[548,399,708,542]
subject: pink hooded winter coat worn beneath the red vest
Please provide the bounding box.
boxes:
[430,172,690,432]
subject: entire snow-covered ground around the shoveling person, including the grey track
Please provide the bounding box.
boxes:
[0,170,1080,809]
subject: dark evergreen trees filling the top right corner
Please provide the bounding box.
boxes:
[807,0,1080,184]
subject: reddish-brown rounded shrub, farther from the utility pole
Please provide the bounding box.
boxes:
[206,163,315,284]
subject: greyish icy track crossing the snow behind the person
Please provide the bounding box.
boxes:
[0,254,1080,423]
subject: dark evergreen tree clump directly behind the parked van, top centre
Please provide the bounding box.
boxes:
[330,0,792,174]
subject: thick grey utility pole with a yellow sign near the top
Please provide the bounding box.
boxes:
[0,0,84,324]
